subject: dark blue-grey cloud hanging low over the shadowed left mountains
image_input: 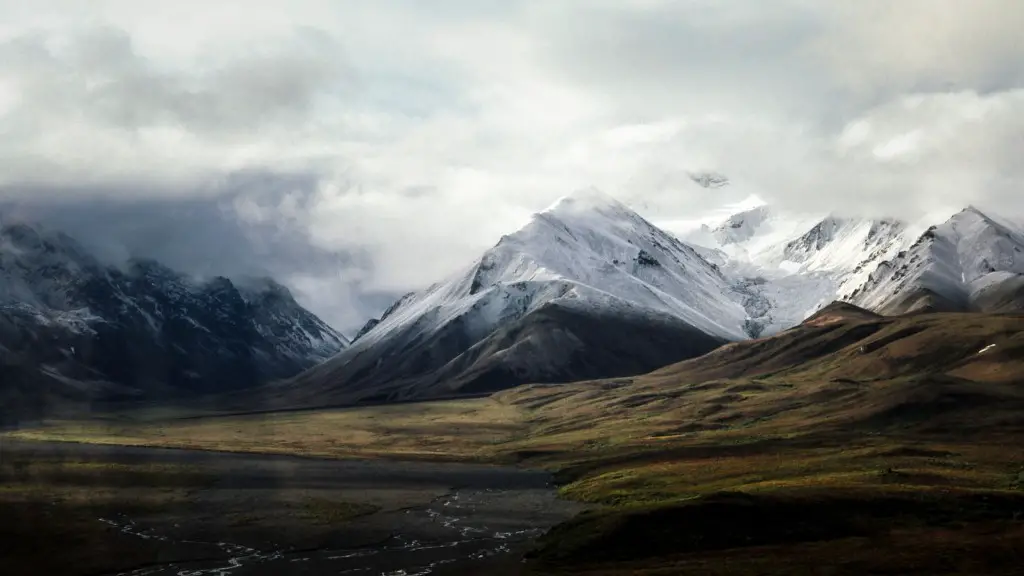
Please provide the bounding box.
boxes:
[0,173,399,333]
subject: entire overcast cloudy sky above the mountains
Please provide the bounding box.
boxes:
[0,0,1024,331]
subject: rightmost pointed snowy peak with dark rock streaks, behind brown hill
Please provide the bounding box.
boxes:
[849,207,1024,313]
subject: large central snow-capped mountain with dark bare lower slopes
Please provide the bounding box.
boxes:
[280,190,748,400]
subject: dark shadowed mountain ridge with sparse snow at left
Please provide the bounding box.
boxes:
[0,219,347,416]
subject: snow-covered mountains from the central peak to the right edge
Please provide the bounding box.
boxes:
[266,186,1024,405]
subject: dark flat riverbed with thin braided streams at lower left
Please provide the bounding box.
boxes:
[0,440,582,576]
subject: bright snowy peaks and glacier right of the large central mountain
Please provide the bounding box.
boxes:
[684,196,1024,325]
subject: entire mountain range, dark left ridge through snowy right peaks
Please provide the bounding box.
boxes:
[0,186,1024,410]
